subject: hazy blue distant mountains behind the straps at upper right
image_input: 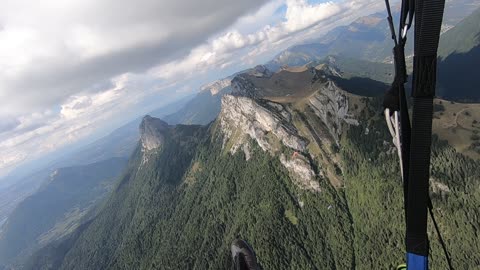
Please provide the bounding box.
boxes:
[267,0,480,68]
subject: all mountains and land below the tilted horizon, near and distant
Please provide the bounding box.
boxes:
[0,0,480,270]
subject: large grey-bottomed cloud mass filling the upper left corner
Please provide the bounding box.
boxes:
[0,0,267,115]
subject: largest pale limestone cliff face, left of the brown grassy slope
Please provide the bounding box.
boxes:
[219,95,320,192]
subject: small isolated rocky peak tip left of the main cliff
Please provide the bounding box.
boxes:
[140,115,169,151]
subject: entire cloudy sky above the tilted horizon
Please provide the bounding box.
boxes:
[0,0,383,177]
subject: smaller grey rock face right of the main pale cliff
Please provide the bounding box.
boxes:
[309,80,358,144]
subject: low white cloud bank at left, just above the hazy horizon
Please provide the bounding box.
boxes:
[0,70,182,176]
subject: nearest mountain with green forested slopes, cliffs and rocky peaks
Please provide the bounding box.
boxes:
[29,65,480,269]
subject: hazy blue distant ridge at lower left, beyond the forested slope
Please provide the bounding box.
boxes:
[0,158,127,265]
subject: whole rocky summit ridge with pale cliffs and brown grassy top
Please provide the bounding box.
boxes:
[219,64,366,191]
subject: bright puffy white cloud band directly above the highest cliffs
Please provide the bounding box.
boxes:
[151,0,379,79]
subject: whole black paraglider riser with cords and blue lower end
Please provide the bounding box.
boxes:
[384,0,453,269]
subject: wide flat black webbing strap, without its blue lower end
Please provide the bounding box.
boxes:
[406,0,445,256]
